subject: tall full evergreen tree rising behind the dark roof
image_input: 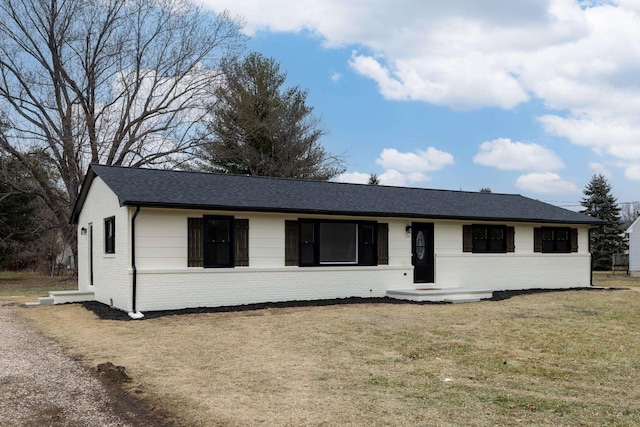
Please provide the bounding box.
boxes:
[200,53,344,180]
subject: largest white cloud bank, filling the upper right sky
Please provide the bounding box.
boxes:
[201,0,640,170]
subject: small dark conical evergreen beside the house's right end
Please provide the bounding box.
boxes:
[580,175,627,270]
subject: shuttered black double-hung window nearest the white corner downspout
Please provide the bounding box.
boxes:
[187,215,249,268]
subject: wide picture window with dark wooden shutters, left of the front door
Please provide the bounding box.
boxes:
[285,219,382,266]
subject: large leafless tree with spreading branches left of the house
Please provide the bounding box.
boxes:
[0,0,244,266]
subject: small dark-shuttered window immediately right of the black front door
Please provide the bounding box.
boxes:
[462,224,515,253]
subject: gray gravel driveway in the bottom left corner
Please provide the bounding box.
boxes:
[0,301,158,427]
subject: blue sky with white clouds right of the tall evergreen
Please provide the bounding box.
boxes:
[203,0,640,209]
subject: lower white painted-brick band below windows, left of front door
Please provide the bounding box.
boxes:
[138,266,412,312]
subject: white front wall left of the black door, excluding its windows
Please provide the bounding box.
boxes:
[127,208,413,311]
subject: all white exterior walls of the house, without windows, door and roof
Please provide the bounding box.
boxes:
[78,191,590,312]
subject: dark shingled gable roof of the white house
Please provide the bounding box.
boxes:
[71,164,600,224]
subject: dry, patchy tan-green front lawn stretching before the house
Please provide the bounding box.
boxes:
[17,279,640,426]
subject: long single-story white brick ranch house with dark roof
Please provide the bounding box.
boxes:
[72,165,599,312]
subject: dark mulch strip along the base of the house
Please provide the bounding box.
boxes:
[81,287,624,320]
